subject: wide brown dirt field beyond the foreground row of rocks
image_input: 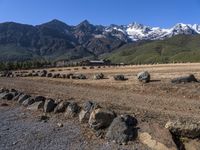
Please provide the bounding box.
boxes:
[0,63,200,149]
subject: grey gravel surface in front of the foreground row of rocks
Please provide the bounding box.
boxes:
[0,104,136,150]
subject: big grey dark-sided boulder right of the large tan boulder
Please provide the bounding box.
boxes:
[105,115,137,144]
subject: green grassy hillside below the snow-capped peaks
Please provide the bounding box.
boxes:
[106,35,200,64]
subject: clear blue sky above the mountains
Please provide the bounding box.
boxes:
[0,0,200,27]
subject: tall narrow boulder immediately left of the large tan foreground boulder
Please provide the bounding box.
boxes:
[79,101,99,122]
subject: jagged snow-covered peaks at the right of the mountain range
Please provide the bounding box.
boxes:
[105,22,200,41]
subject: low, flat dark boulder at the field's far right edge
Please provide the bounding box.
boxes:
[171,74,198,83]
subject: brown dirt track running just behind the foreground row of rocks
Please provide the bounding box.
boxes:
[0,78,200,125]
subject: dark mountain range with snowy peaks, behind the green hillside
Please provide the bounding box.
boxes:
[0,19,200,62]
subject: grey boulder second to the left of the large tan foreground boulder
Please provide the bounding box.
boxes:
[65,102,80,118]
